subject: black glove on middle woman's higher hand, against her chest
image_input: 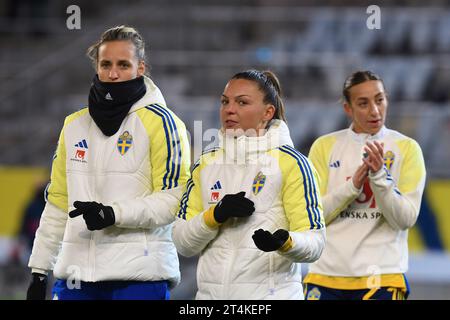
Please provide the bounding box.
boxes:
[214,191,255,223]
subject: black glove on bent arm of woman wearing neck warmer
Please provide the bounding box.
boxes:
[69,201,116,231]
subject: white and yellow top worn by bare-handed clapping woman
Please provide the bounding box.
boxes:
[305,127,425,290]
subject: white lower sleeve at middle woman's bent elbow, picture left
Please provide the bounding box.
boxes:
[172,213,219,257]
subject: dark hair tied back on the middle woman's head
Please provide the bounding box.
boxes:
[231,69,286,122]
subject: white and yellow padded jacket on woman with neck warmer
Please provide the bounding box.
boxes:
[29,77,190,286]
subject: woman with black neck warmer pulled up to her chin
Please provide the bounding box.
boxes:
[27,26,190,300]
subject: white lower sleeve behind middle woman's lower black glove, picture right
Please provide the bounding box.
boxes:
[277,228,326,263]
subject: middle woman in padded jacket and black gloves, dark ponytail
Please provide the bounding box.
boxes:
[173,70,325,299]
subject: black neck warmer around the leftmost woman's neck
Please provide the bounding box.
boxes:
[89,75,147,137]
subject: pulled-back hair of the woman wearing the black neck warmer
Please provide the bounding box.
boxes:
[86,26,145,70]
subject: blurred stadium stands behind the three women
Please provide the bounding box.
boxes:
[0,0,450,299]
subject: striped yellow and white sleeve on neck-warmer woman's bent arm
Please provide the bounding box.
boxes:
[109,105,191,229]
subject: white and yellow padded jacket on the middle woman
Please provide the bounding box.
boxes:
[173,120,325,299]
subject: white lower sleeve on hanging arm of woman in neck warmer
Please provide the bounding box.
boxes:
[28,202,68,274]
